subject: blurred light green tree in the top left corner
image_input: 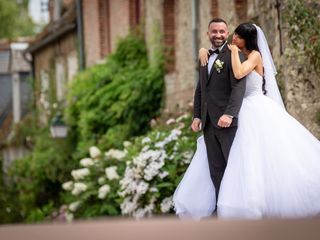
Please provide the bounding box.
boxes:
[0,0,35,39]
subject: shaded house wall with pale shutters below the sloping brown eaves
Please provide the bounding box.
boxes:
[34,32,78,123]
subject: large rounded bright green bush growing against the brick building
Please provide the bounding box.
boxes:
[66,35,164,156]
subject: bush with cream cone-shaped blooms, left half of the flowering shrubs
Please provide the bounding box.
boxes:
[62,147,125,219]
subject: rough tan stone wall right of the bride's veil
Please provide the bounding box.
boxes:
[249,0,320,138]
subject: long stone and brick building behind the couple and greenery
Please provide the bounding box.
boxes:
[29,0,320,136]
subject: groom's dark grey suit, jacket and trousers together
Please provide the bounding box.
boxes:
[194,44,246,206]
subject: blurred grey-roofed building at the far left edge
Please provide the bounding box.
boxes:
[0,39,32,143]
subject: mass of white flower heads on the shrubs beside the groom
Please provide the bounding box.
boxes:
[62,115,193,219]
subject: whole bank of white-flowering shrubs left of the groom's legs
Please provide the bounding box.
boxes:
[63,115,196,219]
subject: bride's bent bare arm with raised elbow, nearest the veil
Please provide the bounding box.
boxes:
[228,45,260,80]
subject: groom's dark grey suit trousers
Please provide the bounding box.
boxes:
[203,114,237,208]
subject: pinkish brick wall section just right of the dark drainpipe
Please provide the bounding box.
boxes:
[83,0,131,66]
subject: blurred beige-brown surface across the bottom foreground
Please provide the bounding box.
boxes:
[0,218,320,240]
